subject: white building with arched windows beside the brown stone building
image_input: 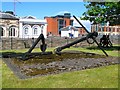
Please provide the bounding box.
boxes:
[19,16,47,38]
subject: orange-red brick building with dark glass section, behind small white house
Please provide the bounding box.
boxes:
[45,13,73,35]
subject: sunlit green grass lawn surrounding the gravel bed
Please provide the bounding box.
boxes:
[0,47,118,88]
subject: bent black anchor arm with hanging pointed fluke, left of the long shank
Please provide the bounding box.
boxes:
[21,34,47,60]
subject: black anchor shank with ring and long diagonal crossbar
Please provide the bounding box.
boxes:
[54,15,108,56]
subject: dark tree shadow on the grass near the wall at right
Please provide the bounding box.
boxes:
[87,46,120,51]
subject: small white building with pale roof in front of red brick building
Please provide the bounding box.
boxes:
[61,26,79,37]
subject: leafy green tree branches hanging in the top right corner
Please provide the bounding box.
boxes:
[81,1,120,25]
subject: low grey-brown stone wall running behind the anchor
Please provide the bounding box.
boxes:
[0,36,120,50]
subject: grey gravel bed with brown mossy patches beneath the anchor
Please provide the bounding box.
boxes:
[3,51,119,79]
